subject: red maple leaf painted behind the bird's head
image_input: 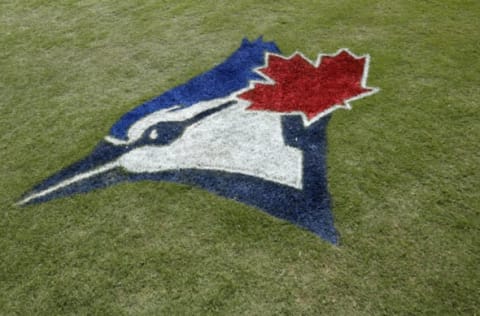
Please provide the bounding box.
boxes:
[238,50,376,124]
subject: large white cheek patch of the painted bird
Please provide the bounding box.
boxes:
[119,99,303,189]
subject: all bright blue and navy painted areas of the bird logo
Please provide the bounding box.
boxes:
[19,39,338,244]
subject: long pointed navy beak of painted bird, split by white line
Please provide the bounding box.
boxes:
[17,141,130,205]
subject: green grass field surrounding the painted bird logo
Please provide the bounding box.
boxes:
[0,0,480,315]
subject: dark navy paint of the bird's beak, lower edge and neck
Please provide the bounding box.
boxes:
[19,115,338,244]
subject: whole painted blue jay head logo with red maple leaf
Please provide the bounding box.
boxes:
[19,38,377,243]
